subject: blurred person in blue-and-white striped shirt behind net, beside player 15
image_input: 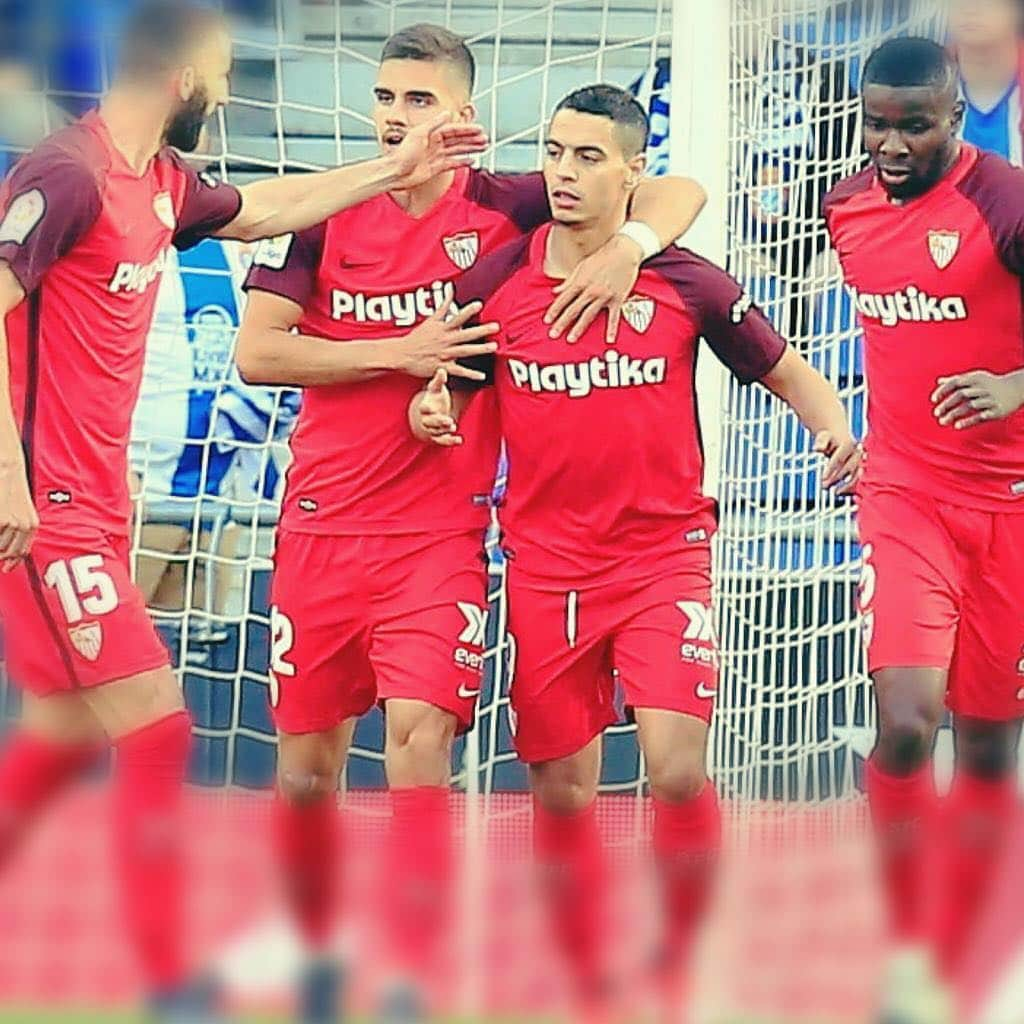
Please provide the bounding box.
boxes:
[131,231,298,610]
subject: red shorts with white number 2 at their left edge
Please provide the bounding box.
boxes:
[270,529,486,733]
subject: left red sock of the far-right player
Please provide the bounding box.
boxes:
[865,759,938,943]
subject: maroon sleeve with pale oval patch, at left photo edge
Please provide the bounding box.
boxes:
[0,146,102,295]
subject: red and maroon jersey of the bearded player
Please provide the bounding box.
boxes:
[0,113,242,534]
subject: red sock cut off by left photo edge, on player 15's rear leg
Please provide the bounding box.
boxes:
[0,732,99,864]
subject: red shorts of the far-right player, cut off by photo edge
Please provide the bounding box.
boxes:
[857,486,1024,721]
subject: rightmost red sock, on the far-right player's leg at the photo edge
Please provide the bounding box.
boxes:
[937,772,1017,971]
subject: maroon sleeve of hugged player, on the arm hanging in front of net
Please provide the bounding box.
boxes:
[646,247,786,384]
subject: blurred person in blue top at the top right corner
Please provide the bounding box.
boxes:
[949,0,1024,166]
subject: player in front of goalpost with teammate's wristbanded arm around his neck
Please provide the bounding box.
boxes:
[410,85,859,1019]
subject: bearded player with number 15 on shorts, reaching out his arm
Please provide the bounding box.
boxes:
[0,0,485,1019]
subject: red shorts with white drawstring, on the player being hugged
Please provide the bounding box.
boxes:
[508,548,719,764]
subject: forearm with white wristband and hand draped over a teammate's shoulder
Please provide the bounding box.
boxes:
[544,176,708,343]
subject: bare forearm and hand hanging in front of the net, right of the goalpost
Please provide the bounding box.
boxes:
[761,348,863,495]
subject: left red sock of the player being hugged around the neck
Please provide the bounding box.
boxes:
[534,799,606,999]
